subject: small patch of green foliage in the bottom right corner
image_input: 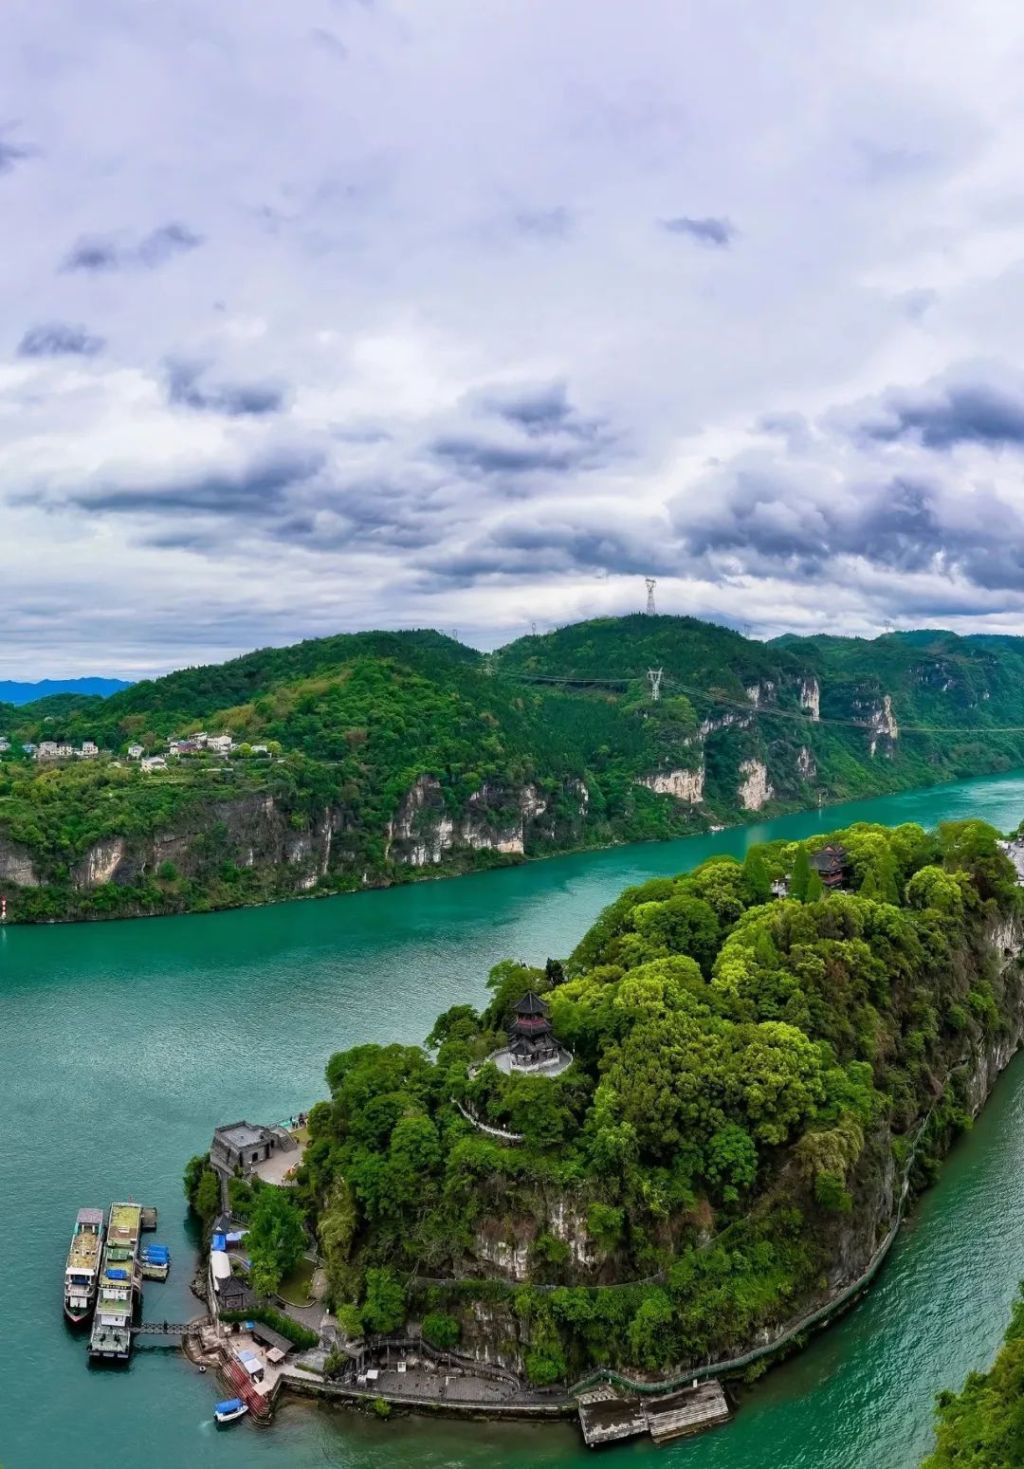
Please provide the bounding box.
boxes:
[921,1290,1024,1469]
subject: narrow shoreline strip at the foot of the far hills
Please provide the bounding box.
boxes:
[0,765,1024,931]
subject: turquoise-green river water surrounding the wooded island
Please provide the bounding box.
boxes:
[0,774,1024,1469]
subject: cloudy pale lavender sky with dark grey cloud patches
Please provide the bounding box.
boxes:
[0,0,1024,677]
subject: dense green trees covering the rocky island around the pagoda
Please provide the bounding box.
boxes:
[285,821,1021,1382]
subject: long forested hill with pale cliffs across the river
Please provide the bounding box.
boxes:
[0,616,1024,918]
